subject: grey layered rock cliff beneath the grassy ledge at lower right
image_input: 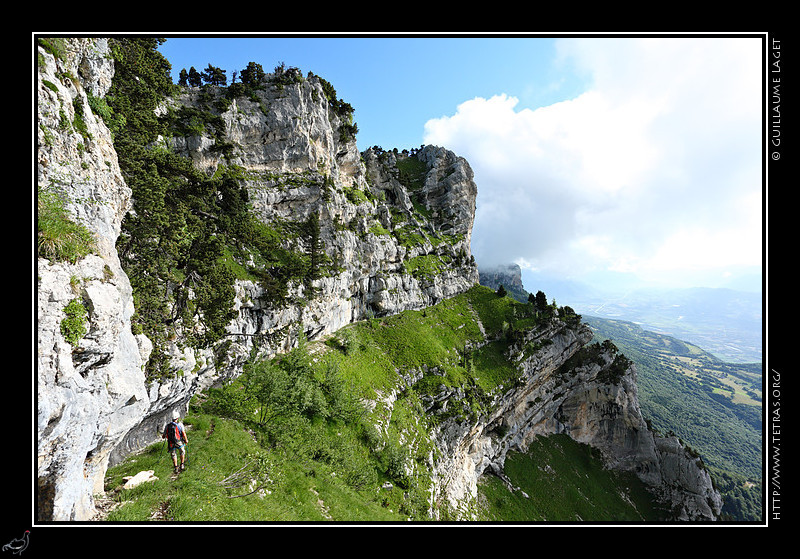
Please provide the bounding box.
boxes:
[428,321,722,521]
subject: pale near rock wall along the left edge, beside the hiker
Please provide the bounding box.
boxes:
[35,39,150,520]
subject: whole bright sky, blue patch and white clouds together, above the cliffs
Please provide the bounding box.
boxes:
[155,37,763,294]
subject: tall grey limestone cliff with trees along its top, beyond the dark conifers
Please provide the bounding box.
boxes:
[159,80,478,368]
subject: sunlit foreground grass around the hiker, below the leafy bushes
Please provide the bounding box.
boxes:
[106,414,406,523]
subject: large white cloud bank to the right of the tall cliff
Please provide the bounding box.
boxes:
[425,39,762,286]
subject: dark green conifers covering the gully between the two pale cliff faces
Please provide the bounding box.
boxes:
[106,38,327,378]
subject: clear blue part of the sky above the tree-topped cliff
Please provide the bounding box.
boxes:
[159,37,582,150]
